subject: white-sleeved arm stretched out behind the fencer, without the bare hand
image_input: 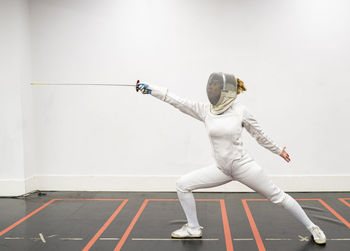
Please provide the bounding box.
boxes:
[242,108,282,155]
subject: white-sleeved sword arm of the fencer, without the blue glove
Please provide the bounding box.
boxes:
[150,85,208,121]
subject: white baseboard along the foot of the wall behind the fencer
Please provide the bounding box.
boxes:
[0,175,350,196]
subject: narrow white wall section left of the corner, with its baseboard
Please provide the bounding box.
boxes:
[0,0,34,195]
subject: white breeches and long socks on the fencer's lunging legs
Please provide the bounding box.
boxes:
[176,155,314,228]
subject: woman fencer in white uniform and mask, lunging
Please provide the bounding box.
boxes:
[136,73,326,244]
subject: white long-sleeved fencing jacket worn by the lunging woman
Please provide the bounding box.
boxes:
[149,85,282,173]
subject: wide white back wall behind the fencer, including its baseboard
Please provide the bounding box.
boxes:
[0,0,350,194]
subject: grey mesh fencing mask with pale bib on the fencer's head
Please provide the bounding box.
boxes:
[207,72,237,115]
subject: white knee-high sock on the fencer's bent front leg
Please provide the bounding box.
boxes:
[177,191,199,228]
